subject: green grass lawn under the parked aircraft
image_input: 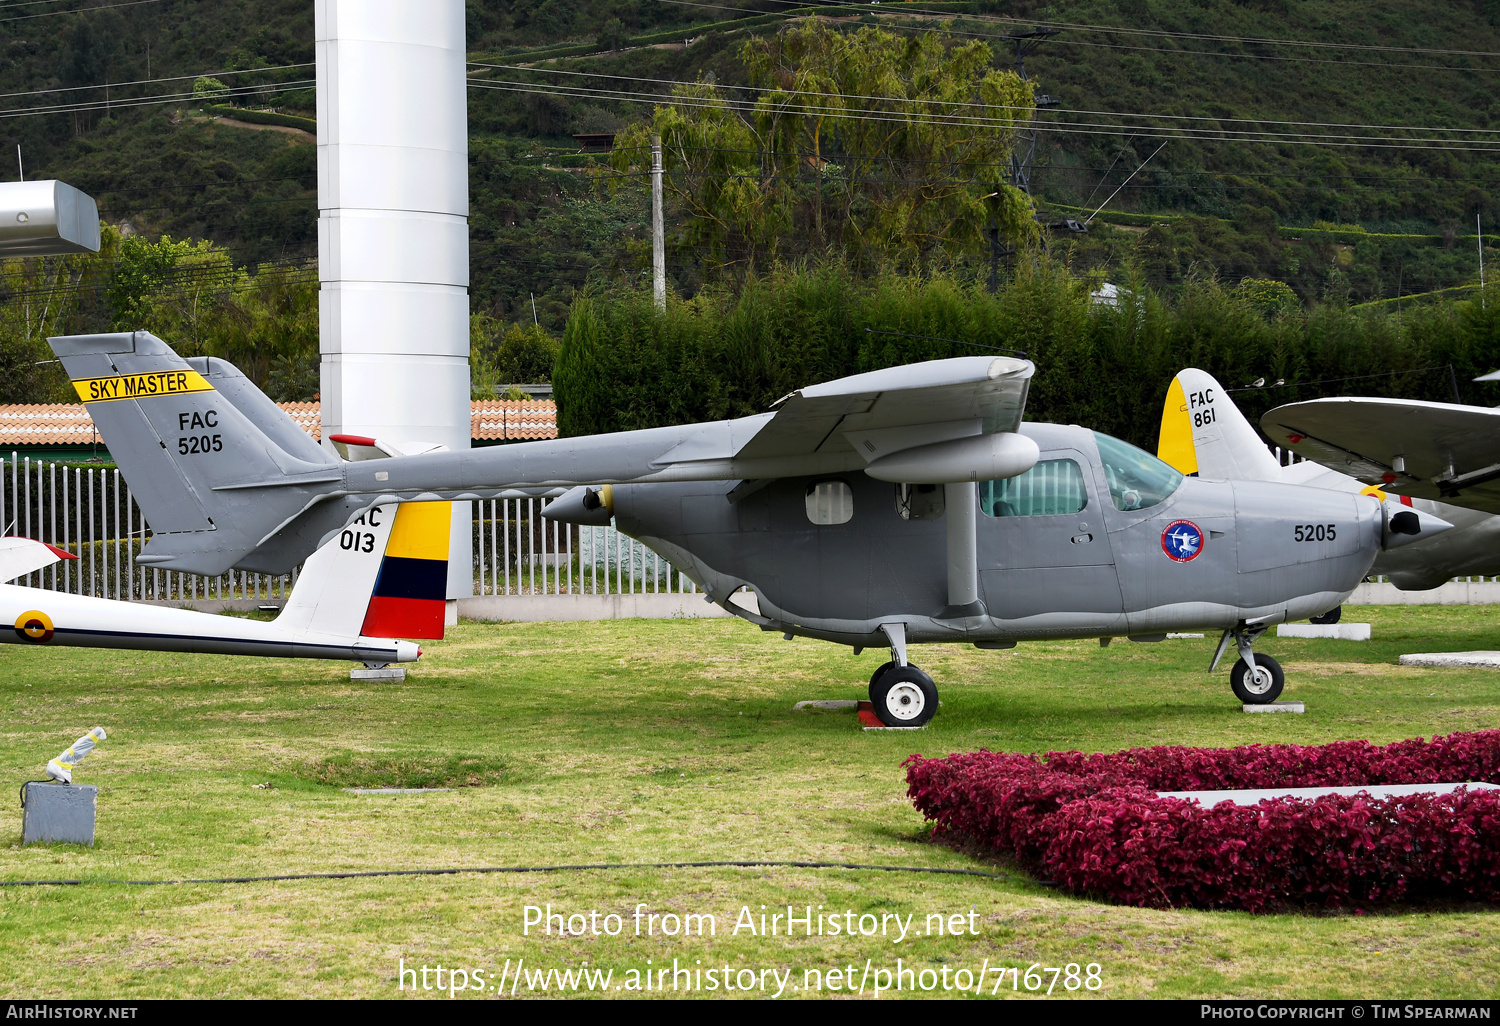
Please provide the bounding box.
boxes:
[0,608,1500,998]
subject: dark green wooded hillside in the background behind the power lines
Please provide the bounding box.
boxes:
[0,0,1500,322]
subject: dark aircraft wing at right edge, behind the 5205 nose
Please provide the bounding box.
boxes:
[1260,398,1500,513]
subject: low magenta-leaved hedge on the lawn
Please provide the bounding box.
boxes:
[905,731,1500,912]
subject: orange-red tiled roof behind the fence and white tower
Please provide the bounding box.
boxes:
[0,399,558,446]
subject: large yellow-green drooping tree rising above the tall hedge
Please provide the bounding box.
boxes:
[612,18,1037,272]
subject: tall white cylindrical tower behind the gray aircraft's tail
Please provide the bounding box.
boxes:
[315,0,473,599]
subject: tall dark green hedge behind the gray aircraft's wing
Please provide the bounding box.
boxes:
[554,261,1500,449]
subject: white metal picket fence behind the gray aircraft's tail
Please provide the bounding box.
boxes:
[0,453,698,602]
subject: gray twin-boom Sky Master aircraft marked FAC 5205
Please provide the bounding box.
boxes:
[50,332,1448,726]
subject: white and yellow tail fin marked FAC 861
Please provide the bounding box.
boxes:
[1157,368,1286,482]
